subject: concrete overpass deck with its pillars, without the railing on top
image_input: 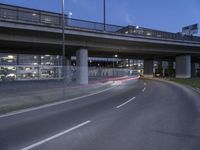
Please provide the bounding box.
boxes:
[0,21,200,84]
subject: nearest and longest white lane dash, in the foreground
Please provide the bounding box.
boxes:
[21,120,91,150]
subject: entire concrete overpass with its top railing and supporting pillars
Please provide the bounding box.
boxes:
[0,4,200,83]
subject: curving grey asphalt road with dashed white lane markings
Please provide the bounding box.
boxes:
[0,80,200,150]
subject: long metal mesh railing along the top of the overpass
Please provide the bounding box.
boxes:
[0,4,200,42]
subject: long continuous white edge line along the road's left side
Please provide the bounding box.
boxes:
[0,81,119,118]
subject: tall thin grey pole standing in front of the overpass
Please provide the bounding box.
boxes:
[62,0,65,78]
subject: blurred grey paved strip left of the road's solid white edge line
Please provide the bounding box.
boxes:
[0,77,133,114]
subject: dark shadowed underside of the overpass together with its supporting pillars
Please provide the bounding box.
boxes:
[0,41,200,84]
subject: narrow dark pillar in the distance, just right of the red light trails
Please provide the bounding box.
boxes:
[144,60,153,78]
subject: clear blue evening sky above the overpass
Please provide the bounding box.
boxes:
[0,0,200,32]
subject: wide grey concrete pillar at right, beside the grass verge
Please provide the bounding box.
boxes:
[176,55,191,78]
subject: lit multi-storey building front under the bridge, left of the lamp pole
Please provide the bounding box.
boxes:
[0,53,62,81]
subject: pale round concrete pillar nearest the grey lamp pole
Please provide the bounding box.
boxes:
[76,48,88,84]
